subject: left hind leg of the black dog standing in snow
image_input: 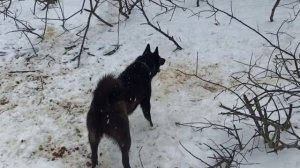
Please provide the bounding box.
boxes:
[89,129,103,168]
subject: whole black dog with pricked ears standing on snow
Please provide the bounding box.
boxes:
[87,44,165,168]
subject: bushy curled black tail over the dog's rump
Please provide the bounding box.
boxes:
[93,74,123,110]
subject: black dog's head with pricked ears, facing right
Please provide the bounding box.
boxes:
[136,44,166,76]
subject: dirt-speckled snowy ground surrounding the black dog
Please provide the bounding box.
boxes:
[0,0,300,168]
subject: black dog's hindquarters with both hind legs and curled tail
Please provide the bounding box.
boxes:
[87,75,131,168]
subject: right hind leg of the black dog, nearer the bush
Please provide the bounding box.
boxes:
[107,122,131,168]
